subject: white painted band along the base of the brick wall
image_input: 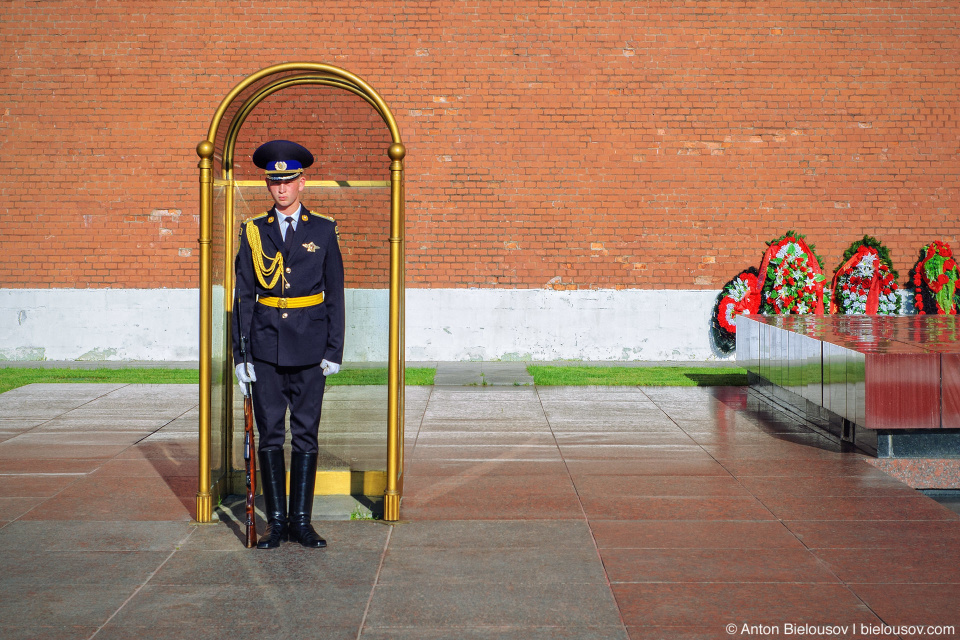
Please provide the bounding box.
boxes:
[0,289,719,362]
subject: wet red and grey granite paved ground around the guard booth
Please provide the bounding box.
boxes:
[0,372,960,640]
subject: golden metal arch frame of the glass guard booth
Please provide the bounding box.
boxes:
[196,62,406,522]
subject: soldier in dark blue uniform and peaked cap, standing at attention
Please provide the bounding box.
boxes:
[233,140,344,549]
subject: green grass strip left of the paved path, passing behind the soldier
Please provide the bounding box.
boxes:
[0,367,436,393]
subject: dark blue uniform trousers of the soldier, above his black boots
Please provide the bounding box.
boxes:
[253,358,326,453]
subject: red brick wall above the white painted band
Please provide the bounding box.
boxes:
[0,0,960,289]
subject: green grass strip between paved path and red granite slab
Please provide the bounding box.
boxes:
[527,365,747,387]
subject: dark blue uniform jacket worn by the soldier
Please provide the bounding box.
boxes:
[233,207,345,367]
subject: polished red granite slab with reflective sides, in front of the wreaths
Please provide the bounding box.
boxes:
[737,315,960,430]
